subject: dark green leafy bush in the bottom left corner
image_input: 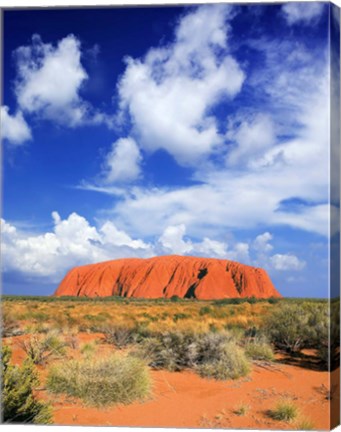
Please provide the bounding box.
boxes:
[1,345,52,424]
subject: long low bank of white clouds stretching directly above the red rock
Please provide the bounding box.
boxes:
[1,212,305,283]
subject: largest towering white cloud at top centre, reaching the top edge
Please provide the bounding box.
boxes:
[118,5,244,165]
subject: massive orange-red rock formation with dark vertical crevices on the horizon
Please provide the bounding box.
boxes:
[54,255,281,300]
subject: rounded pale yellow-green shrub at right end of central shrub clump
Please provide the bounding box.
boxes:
[196,341,250,380]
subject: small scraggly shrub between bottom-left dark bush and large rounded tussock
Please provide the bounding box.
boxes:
[20,331,66,364]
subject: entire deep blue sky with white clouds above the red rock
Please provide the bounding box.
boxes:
[1,3,337,297]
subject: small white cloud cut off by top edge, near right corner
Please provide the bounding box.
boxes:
[282,2,324,25]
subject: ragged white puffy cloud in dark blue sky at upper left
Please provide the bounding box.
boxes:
[14,34,109,127]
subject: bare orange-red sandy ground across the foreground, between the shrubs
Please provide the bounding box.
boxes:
[6,334,339,430]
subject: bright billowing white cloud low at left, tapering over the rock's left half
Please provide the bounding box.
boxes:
[1,212,152,282]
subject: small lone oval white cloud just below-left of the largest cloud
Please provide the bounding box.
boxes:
[103,138,142,183]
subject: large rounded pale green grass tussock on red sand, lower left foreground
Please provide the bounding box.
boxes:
[47,354,151,406]
